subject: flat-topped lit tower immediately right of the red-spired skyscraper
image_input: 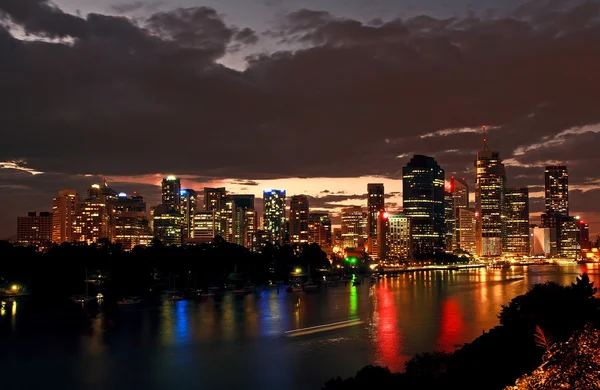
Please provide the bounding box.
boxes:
[503,187,530,256]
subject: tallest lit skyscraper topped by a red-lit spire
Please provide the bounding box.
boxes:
[475,138,506,256]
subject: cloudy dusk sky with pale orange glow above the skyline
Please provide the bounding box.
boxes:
[0,0,600,238]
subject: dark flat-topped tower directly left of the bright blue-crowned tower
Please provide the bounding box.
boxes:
[224,194,257,246]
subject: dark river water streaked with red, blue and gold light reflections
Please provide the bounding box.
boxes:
[0,265,600,390]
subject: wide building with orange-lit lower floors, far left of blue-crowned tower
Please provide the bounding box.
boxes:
[112,192,153,251]
